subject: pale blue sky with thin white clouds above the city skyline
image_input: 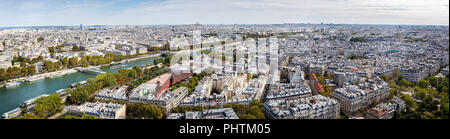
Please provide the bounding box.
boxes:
[0,0,449,27]
